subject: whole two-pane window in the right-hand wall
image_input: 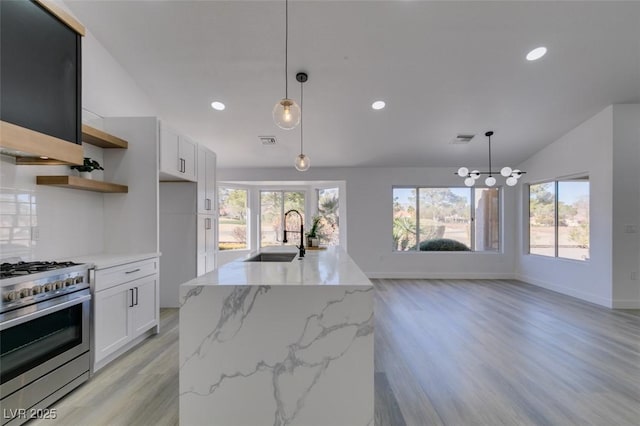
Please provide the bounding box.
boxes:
[529,177,589,260]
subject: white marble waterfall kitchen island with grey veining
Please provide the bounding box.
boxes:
[179,247,374,426]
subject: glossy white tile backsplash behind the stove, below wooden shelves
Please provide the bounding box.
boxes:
[0,151,104,260]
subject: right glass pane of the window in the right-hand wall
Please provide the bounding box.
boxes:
[558,179,589,260]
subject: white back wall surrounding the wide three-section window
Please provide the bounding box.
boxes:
[218,167,516,278]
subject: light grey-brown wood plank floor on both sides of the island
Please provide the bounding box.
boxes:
[33,280,640,426]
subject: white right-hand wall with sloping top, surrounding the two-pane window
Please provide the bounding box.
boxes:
[518,107,613,306]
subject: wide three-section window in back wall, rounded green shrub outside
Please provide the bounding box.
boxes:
[393,187,500,251]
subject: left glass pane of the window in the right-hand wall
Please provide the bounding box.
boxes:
[529,182,556,256]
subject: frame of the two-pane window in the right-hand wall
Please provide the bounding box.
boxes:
[524,173,591,262]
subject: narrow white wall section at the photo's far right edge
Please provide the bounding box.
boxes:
[613,105,640,309]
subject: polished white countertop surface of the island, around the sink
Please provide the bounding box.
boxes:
[183,246,372,287]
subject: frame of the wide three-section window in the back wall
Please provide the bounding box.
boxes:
[391,185,504,254]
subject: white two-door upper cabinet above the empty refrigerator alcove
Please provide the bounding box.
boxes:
[160,123,198,182]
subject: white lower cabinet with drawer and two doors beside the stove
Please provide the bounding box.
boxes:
[92,258,160,371]
